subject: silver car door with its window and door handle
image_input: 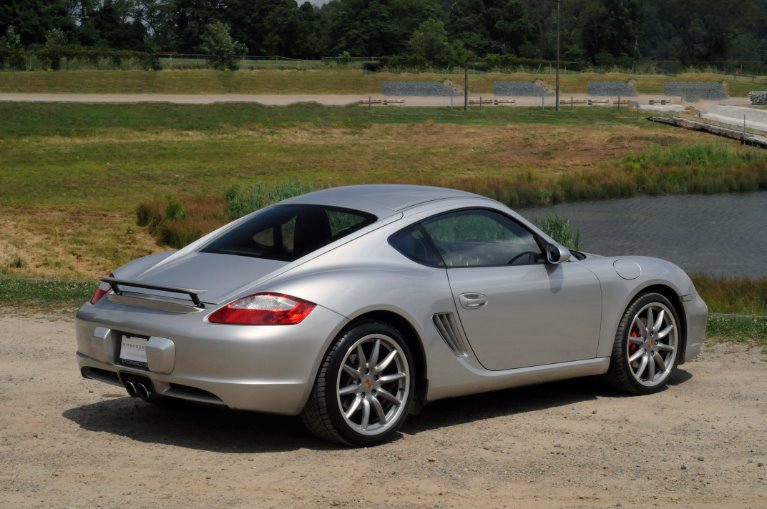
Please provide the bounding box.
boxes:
[422,209,602,370]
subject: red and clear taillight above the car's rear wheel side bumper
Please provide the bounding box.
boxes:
[208,293,317,325]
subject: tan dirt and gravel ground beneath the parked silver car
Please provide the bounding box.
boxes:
[0,309,767,508]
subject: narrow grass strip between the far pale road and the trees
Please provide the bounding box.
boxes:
[0,69,765,97]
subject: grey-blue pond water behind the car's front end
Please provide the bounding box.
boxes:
[519,192,767,277]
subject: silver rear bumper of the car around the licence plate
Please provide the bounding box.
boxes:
[76,303,345,415]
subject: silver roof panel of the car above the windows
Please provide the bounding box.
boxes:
[281,184,480,218]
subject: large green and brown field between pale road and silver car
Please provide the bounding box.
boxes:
[0,103,767,279]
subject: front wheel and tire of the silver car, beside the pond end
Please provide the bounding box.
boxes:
[606,293,683,394]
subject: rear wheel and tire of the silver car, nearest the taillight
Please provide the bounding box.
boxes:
[301,322,416,447]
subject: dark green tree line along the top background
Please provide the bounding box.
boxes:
[0,0,767,68]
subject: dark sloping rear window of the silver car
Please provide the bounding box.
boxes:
[202,205,376,262]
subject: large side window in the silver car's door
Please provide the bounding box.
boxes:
[422,209,544,267]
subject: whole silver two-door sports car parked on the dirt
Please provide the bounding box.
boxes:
[77,185,707,446]
